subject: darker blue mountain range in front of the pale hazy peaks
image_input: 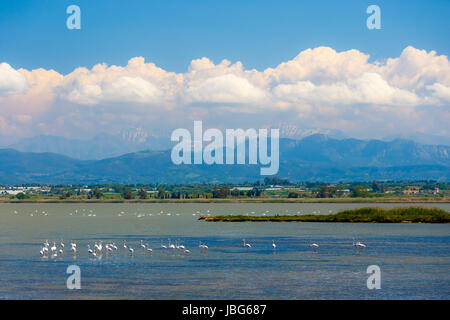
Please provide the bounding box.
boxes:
[0,134,450,185]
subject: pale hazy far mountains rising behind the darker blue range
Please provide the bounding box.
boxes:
[4,123,450,160]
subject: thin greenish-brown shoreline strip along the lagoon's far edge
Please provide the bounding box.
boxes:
[0,197,450,204]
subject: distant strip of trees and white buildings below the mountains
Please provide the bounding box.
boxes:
[0,177,450,202]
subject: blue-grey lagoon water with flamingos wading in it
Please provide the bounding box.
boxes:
[0,204,450,299]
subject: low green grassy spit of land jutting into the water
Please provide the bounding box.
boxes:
[199,207,450,223]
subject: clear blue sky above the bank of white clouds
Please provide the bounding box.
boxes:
[0,0,450,74]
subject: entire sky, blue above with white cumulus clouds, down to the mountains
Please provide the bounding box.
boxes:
[0,0,450,144]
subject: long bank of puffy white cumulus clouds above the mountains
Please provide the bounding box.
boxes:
[0,47,450,141]
